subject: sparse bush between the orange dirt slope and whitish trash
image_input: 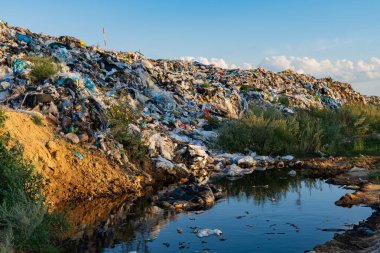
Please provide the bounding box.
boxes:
[108,101,148,162]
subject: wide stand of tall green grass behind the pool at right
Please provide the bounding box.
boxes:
[218,104,380,156]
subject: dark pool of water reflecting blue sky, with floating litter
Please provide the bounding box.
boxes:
[70,171,372,253]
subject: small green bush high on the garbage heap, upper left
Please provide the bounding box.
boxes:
[28,56,59,82]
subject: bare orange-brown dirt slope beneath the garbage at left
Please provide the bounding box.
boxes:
[1,110,141,204]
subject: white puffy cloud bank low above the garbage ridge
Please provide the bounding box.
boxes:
[181,55,380,95]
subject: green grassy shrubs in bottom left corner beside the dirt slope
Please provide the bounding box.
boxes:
[0,110,67,252]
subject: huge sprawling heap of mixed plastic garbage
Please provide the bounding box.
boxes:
[0,22,376,187]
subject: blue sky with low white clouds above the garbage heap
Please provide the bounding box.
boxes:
[0,0,380,95]
